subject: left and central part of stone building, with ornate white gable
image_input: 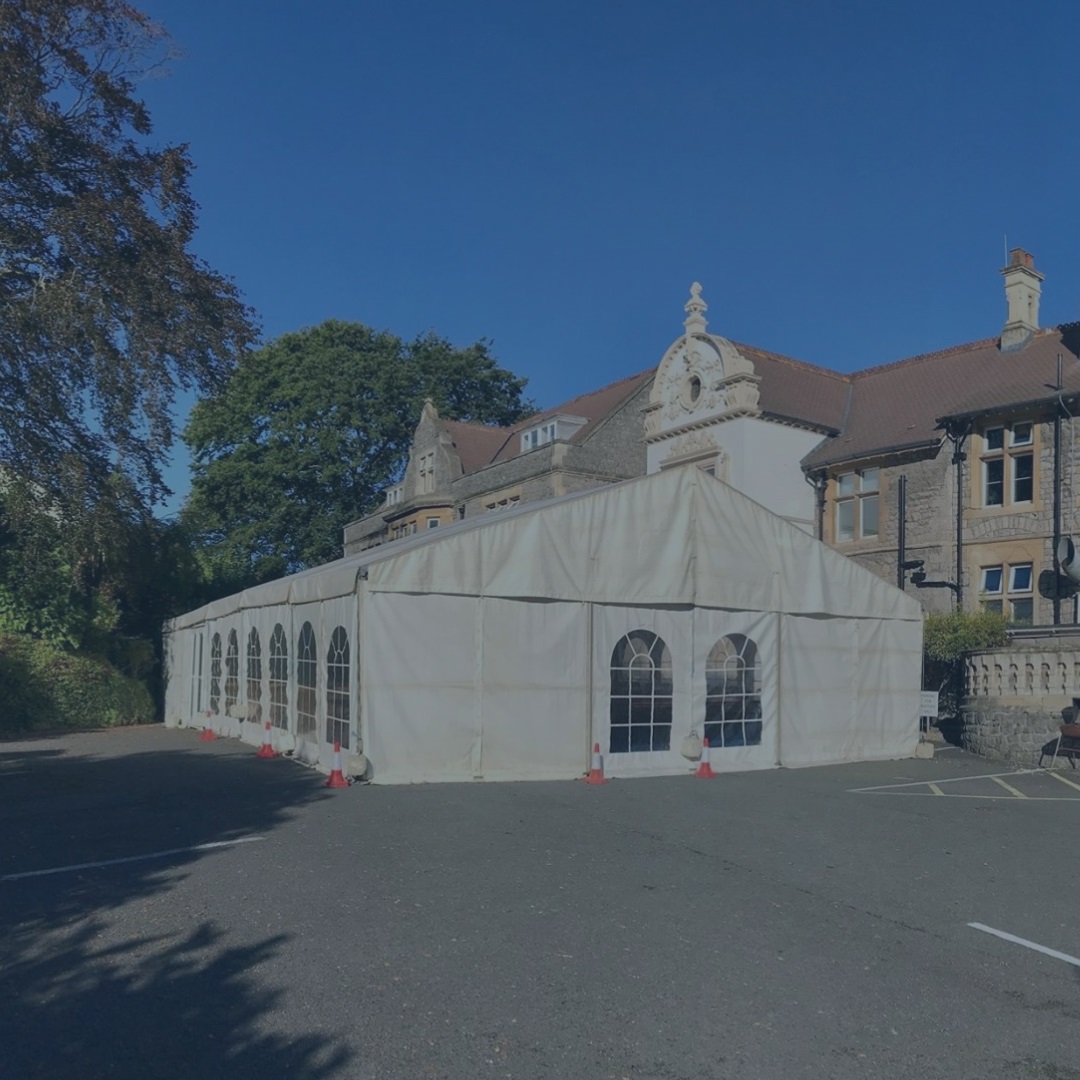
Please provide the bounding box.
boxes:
[345,284,848,555]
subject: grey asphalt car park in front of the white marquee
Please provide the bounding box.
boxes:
[0,728,1080,1080]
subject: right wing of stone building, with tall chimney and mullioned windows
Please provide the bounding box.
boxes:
[802,249,1080,624]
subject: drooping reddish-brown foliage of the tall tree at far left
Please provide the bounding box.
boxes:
[0,0,257,509]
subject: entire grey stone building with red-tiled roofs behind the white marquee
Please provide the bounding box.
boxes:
[345,249,1080,624]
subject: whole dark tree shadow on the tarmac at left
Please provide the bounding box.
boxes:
[0,733,350,1080]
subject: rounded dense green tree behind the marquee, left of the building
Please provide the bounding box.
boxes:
[184,321,531,594]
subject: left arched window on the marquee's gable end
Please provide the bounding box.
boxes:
[609,630,672,754]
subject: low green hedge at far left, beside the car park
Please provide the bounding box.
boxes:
[0,634,154,732]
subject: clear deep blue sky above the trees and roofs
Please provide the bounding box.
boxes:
[140,0,1080,509]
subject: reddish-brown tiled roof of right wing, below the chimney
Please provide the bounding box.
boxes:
[803,324,1080,467]
